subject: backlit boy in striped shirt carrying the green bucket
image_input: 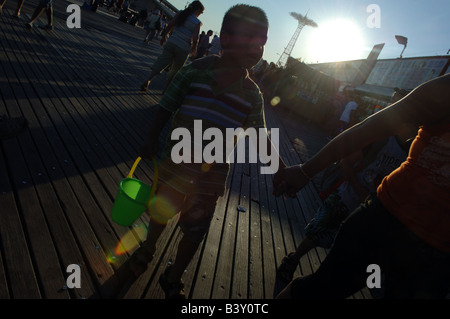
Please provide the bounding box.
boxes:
[104,5,285,298]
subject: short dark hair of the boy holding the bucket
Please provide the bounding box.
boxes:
[220,4,269,35]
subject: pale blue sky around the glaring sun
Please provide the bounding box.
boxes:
[169,0,450,64]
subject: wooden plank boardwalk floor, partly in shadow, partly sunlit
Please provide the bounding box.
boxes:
[0,1,370,299]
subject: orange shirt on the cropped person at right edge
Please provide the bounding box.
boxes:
[378,122,450,252]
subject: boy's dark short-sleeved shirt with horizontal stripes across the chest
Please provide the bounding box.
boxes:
[159,56,265,196]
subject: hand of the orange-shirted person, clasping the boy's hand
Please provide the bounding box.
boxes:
[273,165,309,197]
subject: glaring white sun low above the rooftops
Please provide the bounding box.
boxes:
[310,19,364,62]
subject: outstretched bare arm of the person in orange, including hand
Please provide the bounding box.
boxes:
[274,74,450,197]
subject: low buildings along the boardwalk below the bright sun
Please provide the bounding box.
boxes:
[268,53,450,127]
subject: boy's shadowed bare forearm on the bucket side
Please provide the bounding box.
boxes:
[139,105,172,158]
